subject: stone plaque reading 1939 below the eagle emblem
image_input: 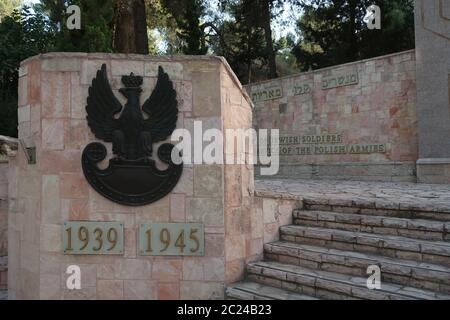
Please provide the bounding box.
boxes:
[62,221,123,255]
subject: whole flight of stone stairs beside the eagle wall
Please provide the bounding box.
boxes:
[226,200,450,300]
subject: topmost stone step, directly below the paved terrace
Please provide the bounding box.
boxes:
[303,198,450,221]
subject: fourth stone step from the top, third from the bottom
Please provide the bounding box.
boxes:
[264,241,450,294]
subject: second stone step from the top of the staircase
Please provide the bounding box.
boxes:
[293,210,450,241]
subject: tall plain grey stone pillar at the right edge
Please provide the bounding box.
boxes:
[414,0,450,184]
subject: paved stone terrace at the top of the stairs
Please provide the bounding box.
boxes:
[255,179,450,212]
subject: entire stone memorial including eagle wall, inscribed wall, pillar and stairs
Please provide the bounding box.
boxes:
[0,0,450,299]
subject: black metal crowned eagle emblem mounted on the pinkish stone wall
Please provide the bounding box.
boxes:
[81,64,183,206]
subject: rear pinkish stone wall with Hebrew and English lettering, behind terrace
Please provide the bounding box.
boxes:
[246,51,418,181]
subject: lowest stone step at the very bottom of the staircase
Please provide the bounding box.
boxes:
[225,281,317,300]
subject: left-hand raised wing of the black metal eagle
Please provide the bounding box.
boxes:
[86,64,122,142]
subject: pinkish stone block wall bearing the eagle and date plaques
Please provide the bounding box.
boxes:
[8,53,255,299]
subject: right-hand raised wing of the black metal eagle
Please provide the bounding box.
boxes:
[142,66,178,142]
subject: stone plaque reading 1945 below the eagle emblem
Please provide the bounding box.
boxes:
[138,223,205,256]
